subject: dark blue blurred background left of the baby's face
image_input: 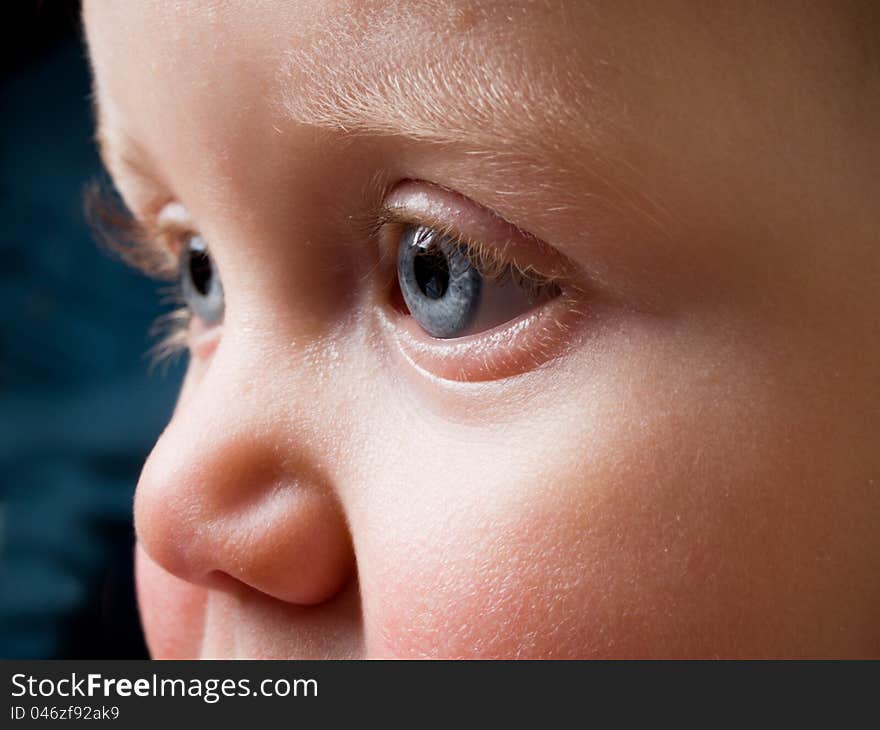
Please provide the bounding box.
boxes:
[0,0,181,658]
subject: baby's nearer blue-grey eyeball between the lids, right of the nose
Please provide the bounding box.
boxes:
[397,225,559,339]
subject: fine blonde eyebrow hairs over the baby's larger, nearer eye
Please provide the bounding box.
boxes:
[278,37,599,168]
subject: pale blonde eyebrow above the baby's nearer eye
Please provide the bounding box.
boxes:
[282,54,592,152]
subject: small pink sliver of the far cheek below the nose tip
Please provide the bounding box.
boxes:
[135,545,207,659]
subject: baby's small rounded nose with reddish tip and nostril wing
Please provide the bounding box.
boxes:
[135,332,354,604]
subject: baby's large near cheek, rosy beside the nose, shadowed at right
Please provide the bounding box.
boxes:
[361,386,877,659]
